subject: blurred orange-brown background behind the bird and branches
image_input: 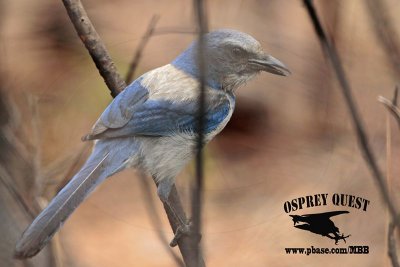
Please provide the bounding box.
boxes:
[0,0,400,267]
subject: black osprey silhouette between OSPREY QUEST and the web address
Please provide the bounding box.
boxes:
[289,210,350,245]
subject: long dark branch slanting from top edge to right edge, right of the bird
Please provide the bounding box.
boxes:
[303,0,400,225]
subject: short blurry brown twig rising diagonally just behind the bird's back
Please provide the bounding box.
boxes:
[125,15,160,84]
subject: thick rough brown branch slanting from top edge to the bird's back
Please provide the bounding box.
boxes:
[62,0,126,97]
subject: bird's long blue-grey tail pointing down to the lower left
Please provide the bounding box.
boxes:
[14,149,115,258]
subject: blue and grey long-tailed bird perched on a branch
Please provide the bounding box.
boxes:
[15,30,290,258]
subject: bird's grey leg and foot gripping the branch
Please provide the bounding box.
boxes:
[157,179,198,247]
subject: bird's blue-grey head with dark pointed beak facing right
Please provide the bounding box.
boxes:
[171,29,290,92]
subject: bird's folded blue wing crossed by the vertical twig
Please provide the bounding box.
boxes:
[86,94,233,139]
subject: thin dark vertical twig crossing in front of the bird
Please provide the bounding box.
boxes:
[192,0,207,266]
